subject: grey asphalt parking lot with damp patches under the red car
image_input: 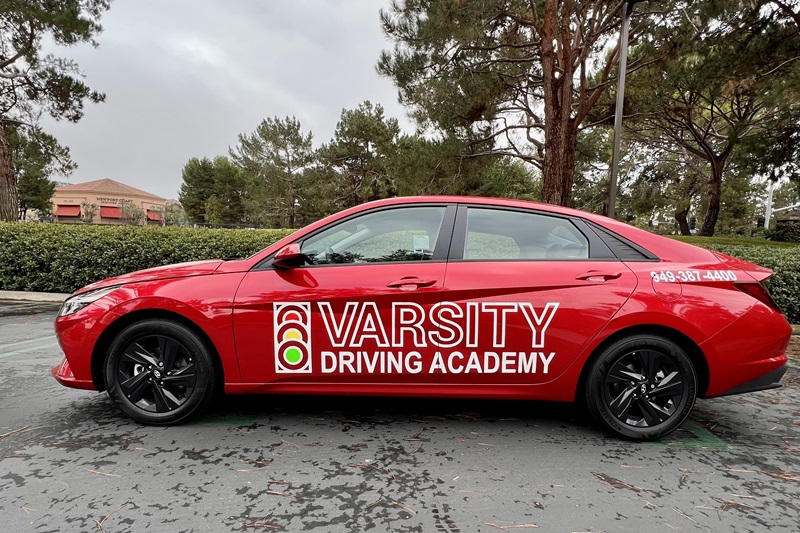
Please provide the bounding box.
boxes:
[0,302,800,533]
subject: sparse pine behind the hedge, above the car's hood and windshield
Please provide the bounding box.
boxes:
[229,117,314,228]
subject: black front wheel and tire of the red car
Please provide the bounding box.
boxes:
[105,318,218,425]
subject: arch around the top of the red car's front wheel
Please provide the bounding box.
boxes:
[91,309,225,391]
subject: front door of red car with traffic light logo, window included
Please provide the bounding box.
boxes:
[233,204,456,384]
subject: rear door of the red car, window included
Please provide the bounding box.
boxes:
[434,205,637,384]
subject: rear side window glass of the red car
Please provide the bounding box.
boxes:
[464,207,589,261]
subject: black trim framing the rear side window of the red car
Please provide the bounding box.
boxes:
[448,203,620,263]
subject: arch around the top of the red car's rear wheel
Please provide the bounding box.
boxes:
[576,324,710,398]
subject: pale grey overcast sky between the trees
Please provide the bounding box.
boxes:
[44,0,411,198]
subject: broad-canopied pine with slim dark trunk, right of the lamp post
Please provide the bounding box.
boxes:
[627,0,800,236]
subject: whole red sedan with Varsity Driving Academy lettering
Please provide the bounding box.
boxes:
[52,196,791,440]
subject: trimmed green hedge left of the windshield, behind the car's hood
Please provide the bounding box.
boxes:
[0,223,291,292]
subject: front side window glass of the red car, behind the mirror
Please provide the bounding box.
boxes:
[300,206,446,265]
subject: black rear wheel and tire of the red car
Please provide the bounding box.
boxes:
[585,334,697,440]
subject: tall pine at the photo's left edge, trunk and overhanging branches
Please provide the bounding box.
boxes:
[0,0,110,221]
